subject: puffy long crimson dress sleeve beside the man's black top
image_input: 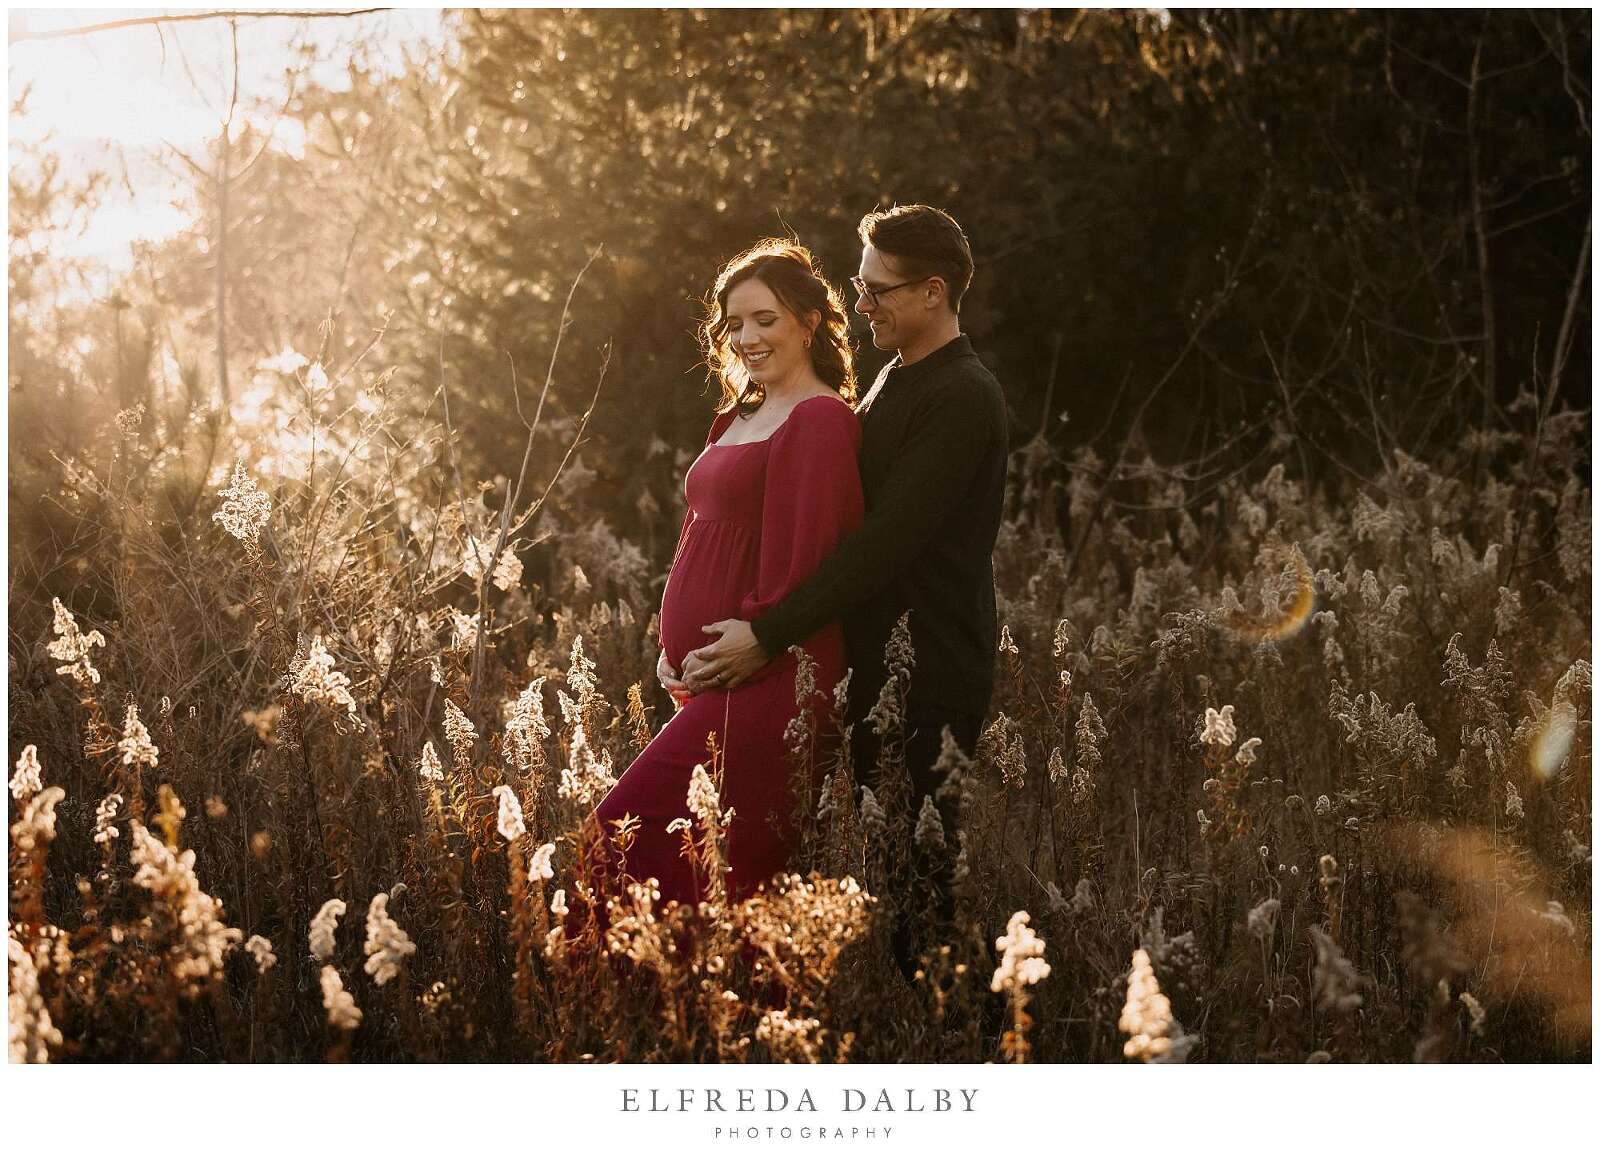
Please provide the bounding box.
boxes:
[741,397,862,630]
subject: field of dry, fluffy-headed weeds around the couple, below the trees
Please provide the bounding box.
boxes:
[10,350,1592,1061]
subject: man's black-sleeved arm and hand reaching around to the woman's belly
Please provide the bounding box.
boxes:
[683,381,994,686]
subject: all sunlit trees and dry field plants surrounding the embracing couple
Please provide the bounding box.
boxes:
[8,10,1592,1061]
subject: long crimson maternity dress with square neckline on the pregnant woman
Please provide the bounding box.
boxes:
[590,395,862,902]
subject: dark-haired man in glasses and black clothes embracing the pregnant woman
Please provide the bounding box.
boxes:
[678,205,1008,966]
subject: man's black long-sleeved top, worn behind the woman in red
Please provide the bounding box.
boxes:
[752,328,1008,718]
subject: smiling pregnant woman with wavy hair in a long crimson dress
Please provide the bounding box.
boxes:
[589,240,861,902]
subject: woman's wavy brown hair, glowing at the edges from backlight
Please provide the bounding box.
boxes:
[699,240,856,416]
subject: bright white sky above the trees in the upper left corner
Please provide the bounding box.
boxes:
[6,8,443,288]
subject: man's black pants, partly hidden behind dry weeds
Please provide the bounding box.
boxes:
[850,707,982,979]
